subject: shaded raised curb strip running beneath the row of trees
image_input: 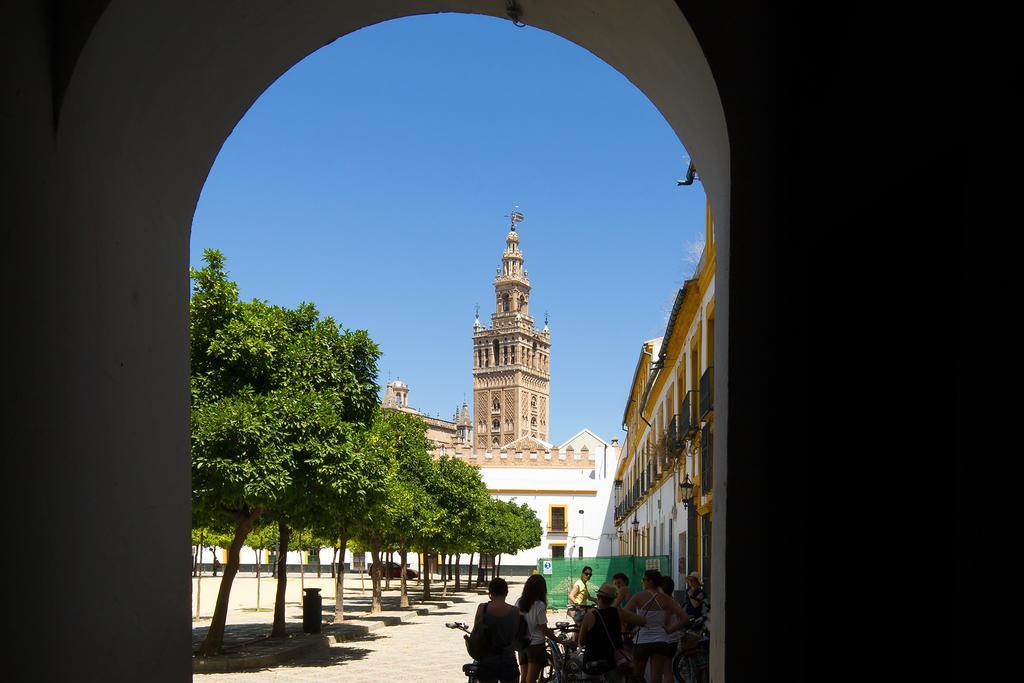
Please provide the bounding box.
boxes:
[193,595,475,674]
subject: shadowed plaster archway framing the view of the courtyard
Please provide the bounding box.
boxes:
[9,0,753,678]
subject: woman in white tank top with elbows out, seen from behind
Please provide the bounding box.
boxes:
[626,569,689,682]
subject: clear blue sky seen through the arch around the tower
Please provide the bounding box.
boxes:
[191,14,705,443]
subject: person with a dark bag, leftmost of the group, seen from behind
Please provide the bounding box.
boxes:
[469,578,523,683]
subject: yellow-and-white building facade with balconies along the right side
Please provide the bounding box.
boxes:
[614,200,716,592]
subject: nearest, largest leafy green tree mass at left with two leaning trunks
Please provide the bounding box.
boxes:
[189,250,379,655]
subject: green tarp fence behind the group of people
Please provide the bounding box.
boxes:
[537,555,669,609]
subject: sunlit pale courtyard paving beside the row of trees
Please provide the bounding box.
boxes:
[193,579,523,683]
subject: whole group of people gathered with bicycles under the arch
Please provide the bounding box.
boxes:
[474,566,705,683]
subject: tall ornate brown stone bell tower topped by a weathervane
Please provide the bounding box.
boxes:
[473,211,551,451]
